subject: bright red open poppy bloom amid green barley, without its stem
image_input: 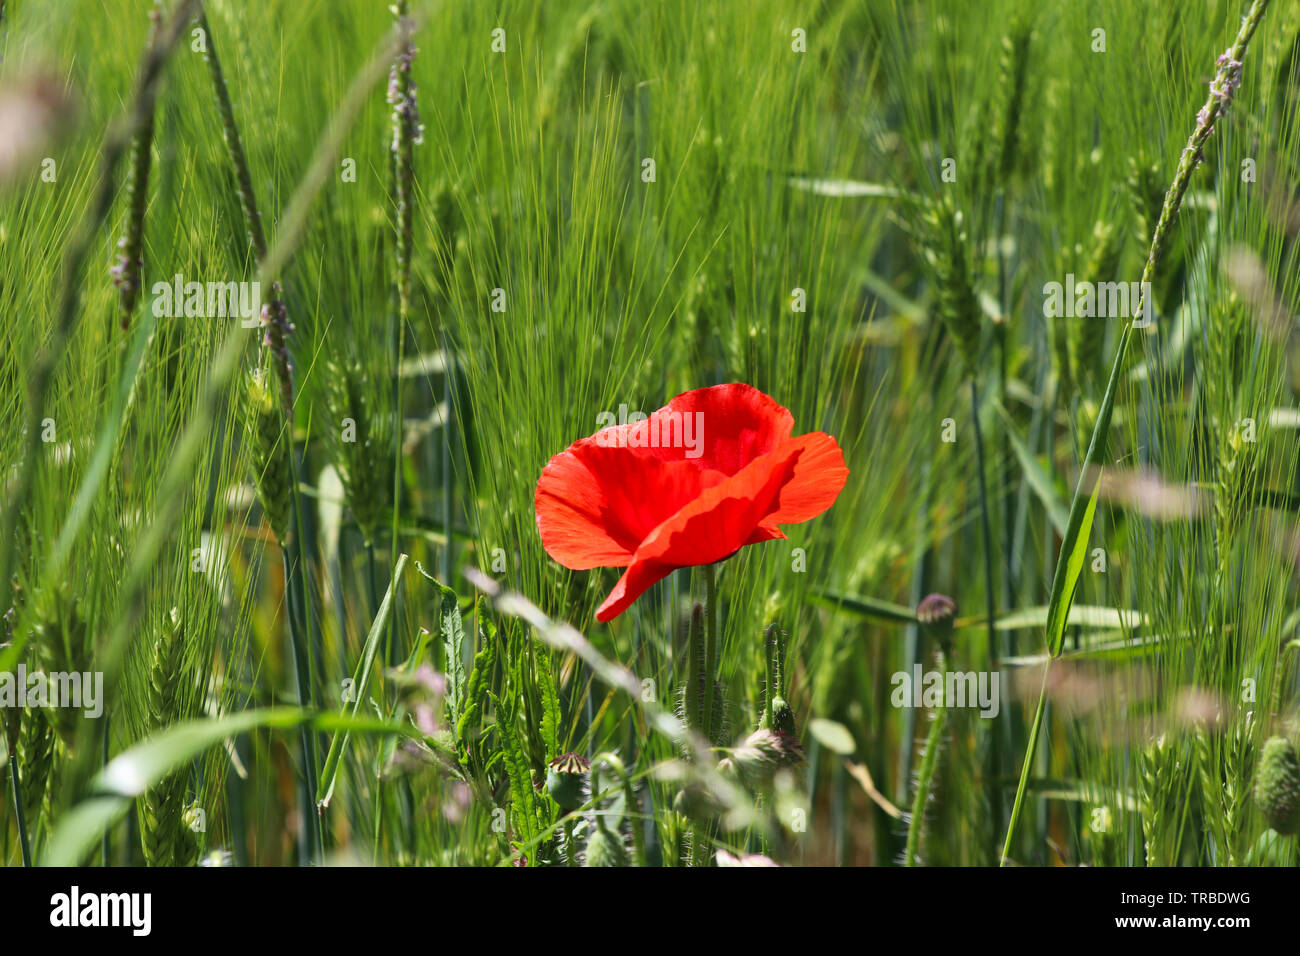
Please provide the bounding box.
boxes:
[534,384,849,620]
